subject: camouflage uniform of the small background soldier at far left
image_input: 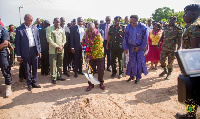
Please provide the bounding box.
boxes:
[9,31,16,65]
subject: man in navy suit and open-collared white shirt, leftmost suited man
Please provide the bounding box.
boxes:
[15,14,41,91]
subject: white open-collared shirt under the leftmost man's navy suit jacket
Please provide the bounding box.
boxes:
[25,25,35,47]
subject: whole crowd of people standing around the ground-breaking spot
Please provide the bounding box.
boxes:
[0,4,200,118]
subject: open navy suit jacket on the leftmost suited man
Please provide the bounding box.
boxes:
[15,24,41,58]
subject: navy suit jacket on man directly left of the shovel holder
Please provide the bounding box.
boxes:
[70,25,80,50]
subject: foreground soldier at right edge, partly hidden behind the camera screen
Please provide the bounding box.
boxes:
[176,4,200,119]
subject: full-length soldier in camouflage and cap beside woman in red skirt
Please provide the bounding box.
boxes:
[158,16,182,79]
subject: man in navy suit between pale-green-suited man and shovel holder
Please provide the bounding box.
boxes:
[70,17,85,78]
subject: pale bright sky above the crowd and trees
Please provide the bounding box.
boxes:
[0,0,200,26]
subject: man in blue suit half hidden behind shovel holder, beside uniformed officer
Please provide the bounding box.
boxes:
[100,16,111,71]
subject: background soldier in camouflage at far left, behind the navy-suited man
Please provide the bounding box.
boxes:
[9,24,16,67]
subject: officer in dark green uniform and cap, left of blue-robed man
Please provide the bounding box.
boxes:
[106,16,124,78]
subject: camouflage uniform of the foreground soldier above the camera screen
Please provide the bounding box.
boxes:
[182,18,200,49]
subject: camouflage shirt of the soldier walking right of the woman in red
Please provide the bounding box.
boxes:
[162,25,182,52]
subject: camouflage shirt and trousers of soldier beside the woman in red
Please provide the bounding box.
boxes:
[160,25,182,73]
